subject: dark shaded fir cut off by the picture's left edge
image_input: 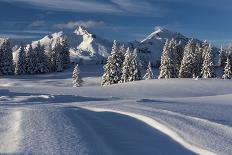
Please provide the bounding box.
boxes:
[0,39,14,75]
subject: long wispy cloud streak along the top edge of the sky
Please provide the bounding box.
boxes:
[0,0,165,16]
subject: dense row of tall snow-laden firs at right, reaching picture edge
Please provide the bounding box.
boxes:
[159,39,232,79]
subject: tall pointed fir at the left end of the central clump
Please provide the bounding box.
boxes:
[102,41,124,86]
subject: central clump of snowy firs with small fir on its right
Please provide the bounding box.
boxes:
[101,41,153,86]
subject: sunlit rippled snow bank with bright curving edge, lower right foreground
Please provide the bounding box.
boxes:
[82,101,232,154]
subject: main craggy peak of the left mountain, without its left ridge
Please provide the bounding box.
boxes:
[66,26,113,63]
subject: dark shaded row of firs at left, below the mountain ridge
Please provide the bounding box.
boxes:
[0,38,70,75]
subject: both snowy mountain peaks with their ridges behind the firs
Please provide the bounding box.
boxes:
[9,26,219,66]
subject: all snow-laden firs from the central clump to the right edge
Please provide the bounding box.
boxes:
[101,39,232,86]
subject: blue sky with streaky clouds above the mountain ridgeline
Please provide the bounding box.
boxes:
[0,0,232,45]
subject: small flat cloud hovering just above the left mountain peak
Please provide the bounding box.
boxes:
[54,20,105,29]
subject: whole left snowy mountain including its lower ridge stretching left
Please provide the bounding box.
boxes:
[25,26,113,64]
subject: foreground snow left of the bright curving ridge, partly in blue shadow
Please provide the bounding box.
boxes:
[0,104,193,155]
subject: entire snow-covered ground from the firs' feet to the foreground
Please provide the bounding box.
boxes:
[0,66,232,155]
